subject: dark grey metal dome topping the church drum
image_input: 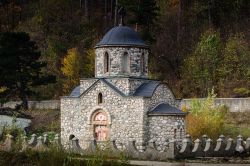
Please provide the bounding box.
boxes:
[96,25,147,47]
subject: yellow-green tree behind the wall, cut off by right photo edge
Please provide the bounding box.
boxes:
[219,34,250,97]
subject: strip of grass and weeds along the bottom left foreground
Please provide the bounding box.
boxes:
[0,148,132,166]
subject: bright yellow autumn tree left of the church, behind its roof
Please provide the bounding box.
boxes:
[61,48,82,93]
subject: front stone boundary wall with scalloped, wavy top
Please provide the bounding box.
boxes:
[0,134,250,161]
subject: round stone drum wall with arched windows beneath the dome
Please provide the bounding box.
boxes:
[95,47,148,77]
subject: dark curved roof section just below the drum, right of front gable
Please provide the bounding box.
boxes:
[133,81,160,97]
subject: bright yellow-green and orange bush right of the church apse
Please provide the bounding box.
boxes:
[187,90,227,138]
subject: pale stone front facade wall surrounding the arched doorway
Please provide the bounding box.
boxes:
[61,82,144,150]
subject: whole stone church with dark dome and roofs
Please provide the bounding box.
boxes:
[61,25,185,148]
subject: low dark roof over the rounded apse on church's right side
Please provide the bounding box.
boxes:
[148,103,186,116]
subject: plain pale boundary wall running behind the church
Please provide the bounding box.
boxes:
[1,98,250,112]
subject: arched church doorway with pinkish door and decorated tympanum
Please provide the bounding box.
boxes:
[92,110,109,141]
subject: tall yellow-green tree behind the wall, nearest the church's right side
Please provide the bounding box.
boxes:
[182,30,222,97]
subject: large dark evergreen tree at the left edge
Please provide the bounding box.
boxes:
[0,32,55,109]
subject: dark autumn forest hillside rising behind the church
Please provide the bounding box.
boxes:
[0,0,250,99]
